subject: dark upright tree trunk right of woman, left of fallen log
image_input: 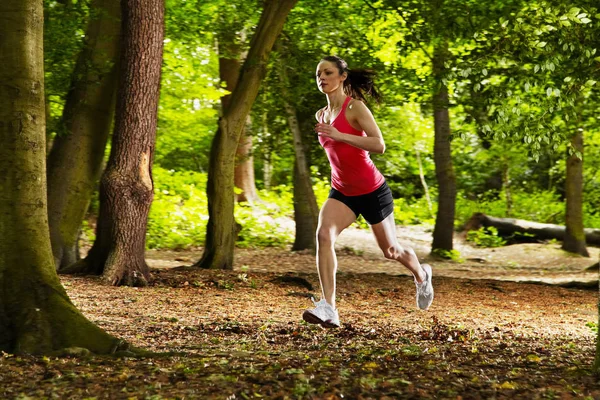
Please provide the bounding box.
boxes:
[432,40,456,252]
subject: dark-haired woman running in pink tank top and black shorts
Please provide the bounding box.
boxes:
[302,56,433,328]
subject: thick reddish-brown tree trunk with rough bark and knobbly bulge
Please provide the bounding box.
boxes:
[65,0,164,286]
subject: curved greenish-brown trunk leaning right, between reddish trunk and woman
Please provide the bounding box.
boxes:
[195,0,297,269]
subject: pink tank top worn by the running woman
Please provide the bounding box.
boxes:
[319,97,385,196]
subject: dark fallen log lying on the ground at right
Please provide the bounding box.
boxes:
[464,213,600,246]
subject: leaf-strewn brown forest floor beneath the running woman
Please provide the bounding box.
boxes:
[0,228,600,399]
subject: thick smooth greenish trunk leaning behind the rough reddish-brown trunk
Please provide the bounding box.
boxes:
[48,0,121,270]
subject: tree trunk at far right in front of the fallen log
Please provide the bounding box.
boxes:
[562,129,590,257]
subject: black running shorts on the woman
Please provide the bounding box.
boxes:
[329,182,394,225]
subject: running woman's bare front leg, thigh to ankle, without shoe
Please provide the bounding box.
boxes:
[317,198,356,309]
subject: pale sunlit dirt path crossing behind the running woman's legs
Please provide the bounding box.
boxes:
[147,226,598,284]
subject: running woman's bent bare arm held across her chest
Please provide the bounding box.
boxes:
[315,100,385,154]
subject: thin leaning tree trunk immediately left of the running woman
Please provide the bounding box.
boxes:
[279,56,319,251]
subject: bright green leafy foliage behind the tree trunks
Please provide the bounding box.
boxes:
[44,1,600,256]
